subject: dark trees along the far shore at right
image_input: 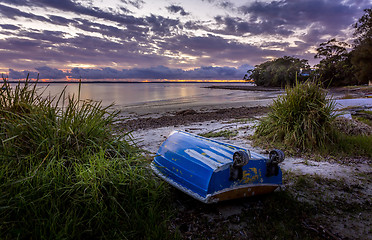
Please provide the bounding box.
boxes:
[244,8,372,87]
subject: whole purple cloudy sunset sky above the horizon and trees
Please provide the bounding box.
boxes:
[0,0,372,80]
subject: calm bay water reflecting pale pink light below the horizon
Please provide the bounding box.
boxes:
[19,83,279,115]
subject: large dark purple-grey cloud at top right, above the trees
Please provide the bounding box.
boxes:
[240,0,360,34]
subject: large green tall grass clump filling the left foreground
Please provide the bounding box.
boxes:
[0,78,170,239]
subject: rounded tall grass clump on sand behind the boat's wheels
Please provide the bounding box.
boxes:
[255,81,335,150]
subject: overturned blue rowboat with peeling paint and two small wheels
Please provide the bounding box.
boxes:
[151,131,284,203]
